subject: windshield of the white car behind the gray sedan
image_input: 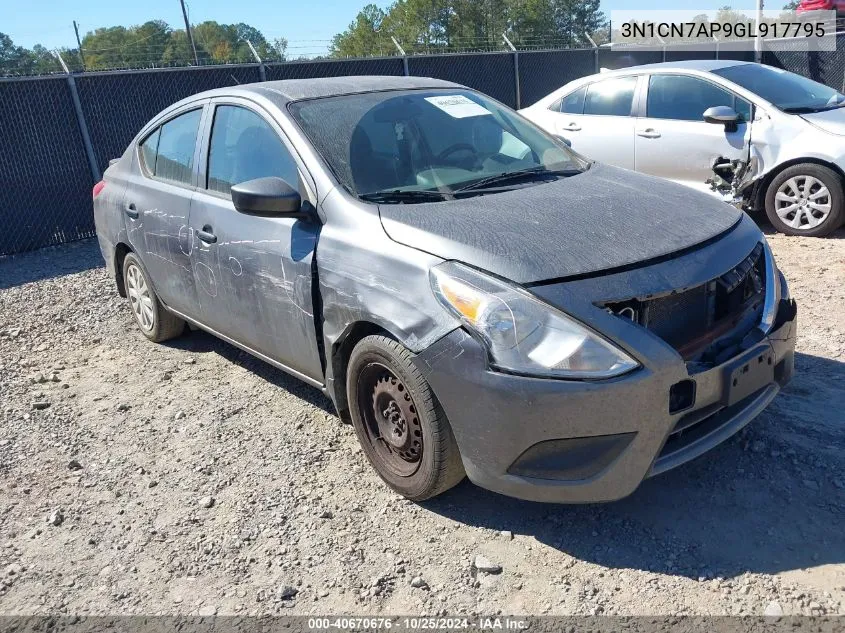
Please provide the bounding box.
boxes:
[713,64,845,114]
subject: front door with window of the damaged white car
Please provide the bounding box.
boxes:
[636,74,752,192]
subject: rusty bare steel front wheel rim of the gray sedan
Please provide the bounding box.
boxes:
[358,363,423,477]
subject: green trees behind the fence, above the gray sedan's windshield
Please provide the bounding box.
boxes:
[331,0,607,57]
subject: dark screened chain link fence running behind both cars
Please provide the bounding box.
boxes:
[0,42,845,256]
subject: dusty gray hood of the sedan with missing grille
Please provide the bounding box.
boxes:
[379,164,742,284]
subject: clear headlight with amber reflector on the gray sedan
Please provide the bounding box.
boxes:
[431,262,639,379]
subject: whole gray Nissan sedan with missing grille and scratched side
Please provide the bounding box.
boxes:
[94,77,796,502]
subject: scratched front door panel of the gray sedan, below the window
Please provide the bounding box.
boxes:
[191,192,322,380]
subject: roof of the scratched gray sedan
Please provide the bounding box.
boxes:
[190,75,464,105]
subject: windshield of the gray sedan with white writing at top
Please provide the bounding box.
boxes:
[289,88,589,203]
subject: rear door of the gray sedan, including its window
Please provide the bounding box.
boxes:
[123,102,204,316]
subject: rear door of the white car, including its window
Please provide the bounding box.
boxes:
[554,76,638,169]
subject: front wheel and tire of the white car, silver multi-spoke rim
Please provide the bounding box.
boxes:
[766,163,845,237]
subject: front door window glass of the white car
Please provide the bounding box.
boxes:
[646,75,750,121]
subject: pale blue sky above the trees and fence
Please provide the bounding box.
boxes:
[0,0,760,55]
